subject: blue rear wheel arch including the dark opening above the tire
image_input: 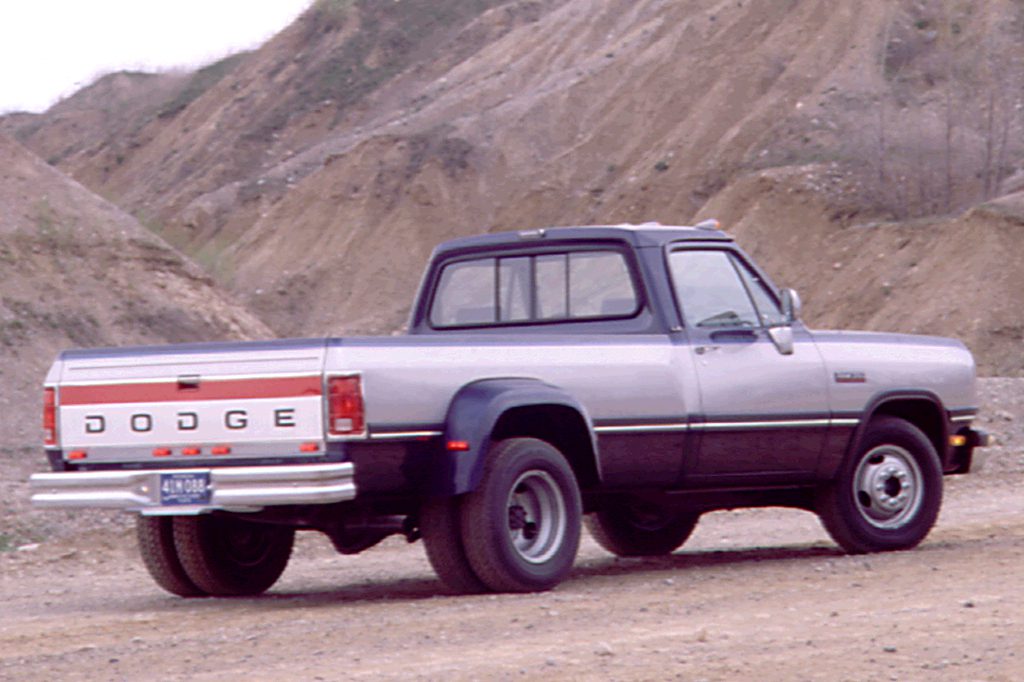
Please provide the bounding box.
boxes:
[430,378,601,496]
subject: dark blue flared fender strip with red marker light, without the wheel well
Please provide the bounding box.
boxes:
[430,377,600,496]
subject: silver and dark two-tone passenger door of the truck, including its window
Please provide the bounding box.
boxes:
[669,247,829,483]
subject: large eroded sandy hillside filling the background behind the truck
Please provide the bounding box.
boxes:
[8,0,1024,373]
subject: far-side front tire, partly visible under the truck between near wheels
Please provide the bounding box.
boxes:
[586,502,700,556]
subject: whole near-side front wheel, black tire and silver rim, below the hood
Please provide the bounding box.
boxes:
[817,417,942,553]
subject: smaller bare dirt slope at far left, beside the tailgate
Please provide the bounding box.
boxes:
[0,135,270,446]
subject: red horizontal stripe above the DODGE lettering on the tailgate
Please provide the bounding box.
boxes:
[60,376,323,404]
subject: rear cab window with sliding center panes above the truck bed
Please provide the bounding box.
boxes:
[428,247,642,329]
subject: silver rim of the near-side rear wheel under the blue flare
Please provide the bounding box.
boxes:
[506,470,568,563]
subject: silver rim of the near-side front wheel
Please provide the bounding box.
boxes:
[853,444,924,529]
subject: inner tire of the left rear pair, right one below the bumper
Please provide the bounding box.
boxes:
[174,514,295,597]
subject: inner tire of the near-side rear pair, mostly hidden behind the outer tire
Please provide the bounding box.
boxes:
[420,498,488,594]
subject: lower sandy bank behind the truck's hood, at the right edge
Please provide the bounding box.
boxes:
[701,166,1024,376]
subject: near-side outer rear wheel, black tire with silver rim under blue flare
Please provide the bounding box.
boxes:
[460,438,583,592]
